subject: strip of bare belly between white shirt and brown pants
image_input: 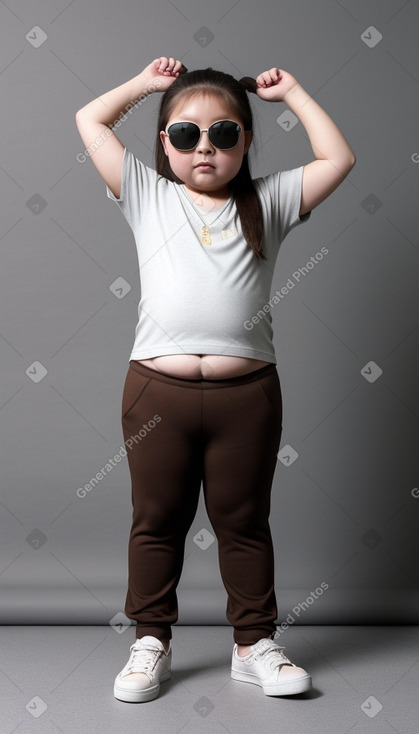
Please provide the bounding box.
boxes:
[137,354,271,380]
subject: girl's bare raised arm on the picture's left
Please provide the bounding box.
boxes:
[76,56,185,199]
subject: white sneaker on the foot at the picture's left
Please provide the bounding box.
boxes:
[114,635,172,703]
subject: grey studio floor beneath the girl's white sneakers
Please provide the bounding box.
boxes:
[0,625,419,734]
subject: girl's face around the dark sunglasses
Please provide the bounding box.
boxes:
[160,94,252,196]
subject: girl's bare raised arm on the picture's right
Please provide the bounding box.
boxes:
[251,67,356,216]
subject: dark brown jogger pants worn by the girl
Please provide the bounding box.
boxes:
[122,360,282,645]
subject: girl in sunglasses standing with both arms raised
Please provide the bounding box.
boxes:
[76,56,355,701]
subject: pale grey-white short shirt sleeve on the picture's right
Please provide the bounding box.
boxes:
[261,166,311,239]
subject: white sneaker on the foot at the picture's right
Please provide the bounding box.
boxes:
[231,637,311,696]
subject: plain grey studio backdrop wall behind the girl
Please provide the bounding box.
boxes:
[0,0,419,625]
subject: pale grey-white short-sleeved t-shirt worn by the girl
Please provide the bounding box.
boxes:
[106,148,311,364]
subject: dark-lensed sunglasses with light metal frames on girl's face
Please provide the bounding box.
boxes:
[165,120,242,150]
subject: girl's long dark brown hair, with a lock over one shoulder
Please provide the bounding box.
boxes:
[155,67,266,260]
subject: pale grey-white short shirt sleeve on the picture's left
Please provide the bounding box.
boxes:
[106,148,158,229]
